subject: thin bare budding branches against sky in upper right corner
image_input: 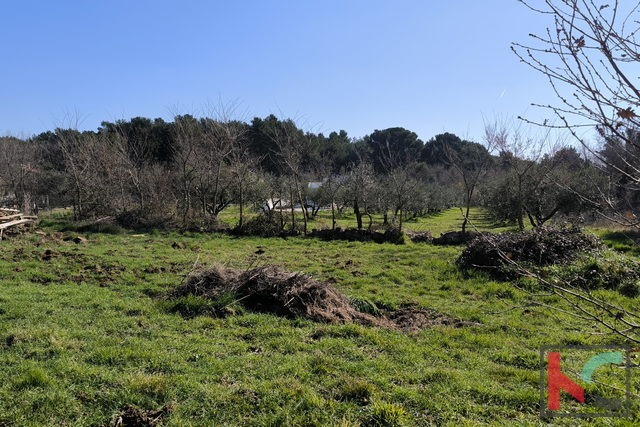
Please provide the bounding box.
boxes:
[512,0,640,228]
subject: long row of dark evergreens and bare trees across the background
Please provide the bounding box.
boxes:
[0,108,638,231]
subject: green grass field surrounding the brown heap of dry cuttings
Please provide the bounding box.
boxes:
[0,210,640,427]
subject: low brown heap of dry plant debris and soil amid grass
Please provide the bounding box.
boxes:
[167,266,477,332]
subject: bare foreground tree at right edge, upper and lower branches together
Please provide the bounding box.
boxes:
[501,0,640,342]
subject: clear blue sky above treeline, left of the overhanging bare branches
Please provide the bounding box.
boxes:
[0,0,555,141]
